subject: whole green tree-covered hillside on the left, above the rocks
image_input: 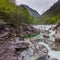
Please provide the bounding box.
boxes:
[0,0,34,27]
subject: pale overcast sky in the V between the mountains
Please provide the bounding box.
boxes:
[16,0,58,15]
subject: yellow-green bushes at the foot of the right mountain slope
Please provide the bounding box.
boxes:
[39,14,60,24]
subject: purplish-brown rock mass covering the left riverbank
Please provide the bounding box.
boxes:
[0,25,40,60]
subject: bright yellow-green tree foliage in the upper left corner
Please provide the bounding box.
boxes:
[0,0,15,13]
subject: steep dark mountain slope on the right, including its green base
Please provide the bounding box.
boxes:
[39,0,60,24]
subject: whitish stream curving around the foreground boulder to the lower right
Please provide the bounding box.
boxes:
[39,42,60,60]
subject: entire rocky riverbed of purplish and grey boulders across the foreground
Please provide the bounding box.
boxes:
[0,25,60,60]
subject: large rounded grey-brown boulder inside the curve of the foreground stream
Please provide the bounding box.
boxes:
[33,44,48,60]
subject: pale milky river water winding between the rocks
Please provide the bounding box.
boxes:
[34,25,60,60]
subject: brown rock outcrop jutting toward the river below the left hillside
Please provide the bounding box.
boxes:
[18,24,39,37]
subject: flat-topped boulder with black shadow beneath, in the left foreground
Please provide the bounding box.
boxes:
[15,41,29,51]
